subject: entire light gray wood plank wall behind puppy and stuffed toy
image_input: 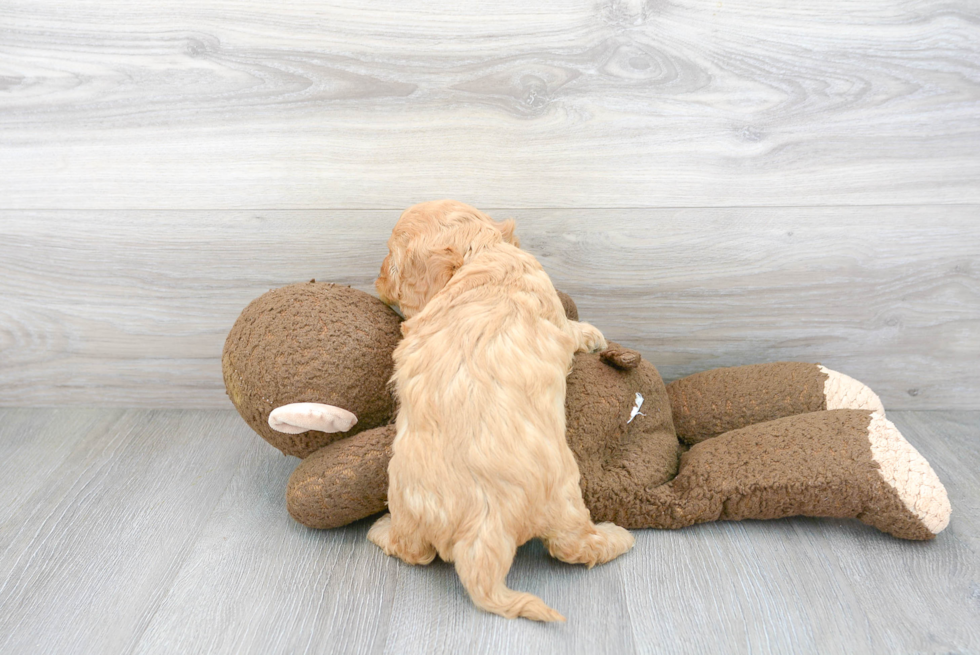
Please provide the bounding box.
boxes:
[0,0,980,409]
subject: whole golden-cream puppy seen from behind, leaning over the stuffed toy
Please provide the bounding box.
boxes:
[368,200,633,621]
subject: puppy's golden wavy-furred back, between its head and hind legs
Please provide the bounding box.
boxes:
[394,246,577,532]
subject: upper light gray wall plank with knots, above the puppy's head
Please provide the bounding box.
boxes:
[0,0,980,209]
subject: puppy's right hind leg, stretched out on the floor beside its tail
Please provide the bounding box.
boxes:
[543,483,635,568]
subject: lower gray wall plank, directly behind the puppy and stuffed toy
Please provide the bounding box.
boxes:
[0,206,980,409]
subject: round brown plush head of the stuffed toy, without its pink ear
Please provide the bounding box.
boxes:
[221,282,401,457]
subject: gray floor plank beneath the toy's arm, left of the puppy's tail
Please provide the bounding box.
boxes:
[134,433,399,654]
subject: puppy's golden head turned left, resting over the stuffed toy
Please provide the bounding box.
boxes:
[374,200,520,318]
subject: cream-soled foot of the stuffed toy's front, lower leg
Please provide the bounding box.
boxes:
[858,412,952,539]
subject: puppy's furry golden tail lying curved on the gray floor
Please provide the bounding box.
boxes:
[453,530,565,621]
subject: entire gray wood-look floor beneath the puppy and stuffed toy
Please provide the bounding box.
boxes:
[0,409,980,655]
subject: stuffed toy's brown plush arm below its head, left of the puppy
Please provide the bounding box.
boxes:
[286,425,395,528]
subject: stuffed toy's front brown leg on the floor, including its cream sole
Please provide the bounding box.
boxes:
[630,409,950,539]
